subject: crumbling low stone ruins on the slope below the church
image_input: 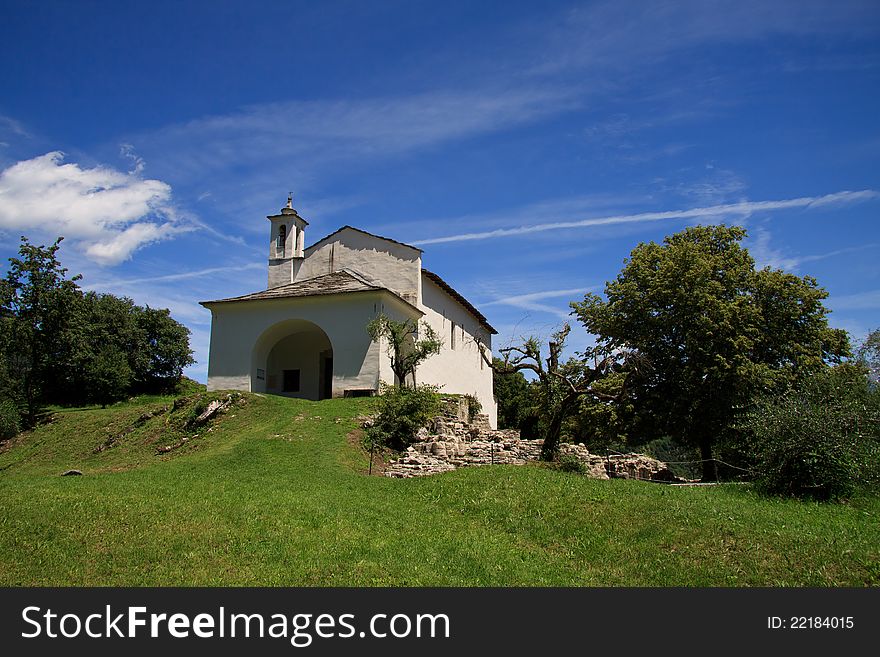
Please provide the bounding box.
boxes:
[385,398,683,482]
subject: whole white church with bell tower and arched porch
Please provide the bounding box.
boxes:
[201,198,497,427]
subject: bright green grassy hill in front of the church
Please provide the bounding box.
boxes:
[0,386,880,586]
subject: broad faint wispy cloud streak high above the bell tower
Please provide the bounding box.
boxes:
[131,85,580,183]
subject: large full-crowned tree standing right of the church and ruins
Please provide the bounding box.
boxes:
[571,226,849,481]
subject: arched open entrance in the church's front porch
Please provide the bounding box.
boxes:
[251,319,333,400]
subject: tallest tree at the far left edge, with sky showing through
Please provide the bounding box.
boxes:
[0,237,81,426]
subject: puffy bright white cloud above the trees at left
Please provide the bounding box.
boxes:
[0,151,190,265]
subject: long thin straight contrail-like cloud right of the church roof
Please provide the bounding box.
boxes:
[409,190,880,246]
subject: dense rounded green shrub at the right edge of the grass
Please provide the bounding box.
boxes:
[745,365,880,500]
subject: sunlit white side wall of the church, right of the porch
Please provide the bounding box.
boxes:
[416,277,498,428]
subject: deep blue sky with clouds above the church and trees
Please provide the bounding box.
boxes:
[0,0,880,381]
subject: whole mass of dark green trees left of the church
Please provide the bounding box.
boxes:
[0,237,194,425]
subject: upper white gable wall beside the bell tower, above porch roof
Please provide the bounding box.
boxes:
[296,228,422,304]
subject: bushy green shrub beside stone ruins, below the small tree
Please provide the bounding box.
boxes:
[366,385,440,451]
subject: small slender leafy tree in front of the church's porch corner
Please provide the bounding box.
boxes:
[367,314,443,388]
